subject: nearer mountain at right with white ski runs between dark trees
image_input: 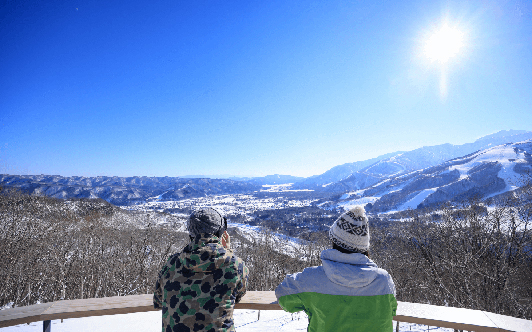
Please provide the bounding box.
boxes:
[339,140,532,212]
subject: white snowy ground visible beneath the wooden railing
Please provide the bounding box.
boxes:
[0,309,453,332]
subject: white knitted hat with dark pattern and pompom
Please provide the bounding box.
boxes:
[329,205,369,253]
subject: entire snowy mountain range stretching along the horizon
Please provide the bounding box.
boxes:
[4,130,532,212]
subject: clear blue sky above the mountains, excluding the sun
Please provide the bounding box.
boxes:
[0,0,532,176]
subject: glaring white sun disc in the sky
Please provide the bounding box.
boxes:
[424,25,464,63]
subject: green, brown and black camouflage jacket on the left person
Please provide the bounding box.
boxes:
[153,235,248,332]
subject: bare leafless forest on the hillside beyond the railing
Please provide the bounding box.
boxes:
[0,186,532,319]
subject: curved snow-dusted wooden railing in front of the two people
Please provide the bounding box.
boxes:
[0,291,532,332]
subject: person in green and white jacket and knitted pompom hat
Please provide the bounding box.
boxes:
[275,206,397,332]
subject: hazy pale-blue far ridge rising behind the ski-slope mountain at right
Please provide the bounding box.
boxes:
[294,130,532,192]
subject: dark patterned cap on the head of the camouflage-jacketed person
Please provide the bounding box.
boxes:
[187,208,227,238]
